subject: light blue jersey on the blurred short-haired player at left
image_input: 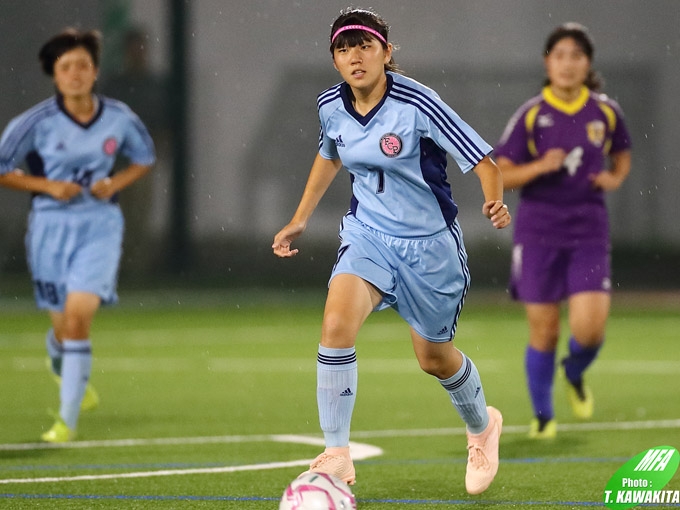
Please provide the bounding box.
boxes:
[0,96,155,213]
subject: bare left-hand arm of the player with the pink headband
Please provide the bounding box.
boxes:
[272,154,342,258]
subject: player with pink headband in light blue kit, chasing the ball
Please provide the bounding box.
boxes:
[272,9,510,494]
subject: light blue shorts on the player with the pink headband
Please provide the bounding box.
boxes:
[330,215,470,342]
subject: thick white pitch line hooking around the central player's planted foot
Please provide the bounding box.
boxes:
[0,435,383,485]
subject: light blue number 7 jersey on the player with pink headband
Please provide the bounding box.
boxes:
[317,72,492,237]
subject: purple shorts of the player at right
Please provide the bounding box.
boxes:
[510,239,611,303]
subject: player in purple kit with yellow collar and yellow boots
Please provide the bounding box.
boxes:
[494,23,631,439]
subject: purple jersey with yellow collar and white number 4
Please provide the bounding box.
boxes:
[494,87,631,246]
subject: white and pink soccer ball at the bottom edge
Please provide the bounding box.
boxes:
[279,472,357,510]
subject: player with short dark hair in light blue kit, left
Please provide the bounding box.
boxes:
[0,29,155,443]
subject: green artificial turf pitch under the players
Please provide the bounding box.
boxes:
[0,289,680,510]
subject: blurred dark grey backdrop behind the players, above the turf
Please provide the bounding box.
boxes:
[0,0,680,295]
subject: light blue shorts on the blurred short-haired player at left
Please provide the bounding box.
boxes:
[26,204,123,311]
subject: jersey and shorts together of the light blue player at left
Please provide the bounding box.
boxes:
[0,96,155,311]
